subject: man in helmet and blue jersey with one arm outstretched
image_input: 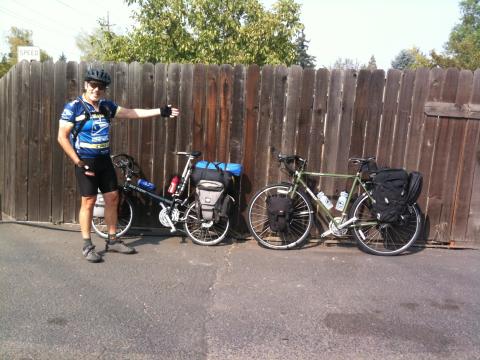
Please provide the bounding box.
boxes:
[58,67,179,262]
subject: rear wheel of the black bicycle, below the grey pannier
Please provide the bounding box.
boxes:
[184,202,230,245]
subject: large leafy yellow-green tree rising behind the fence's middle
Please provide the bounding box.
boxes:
[77,0,303,65]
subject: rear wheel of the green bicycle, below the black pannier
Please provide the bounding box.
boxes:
[350,193,422,255]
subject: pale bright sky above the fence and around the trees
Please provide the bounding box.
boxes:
[0,0,460,70]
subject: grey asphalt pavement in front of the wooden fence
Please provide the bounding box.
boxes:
[0,223,480,359]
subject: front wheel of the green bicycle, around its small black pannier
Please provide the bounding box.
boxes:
[248,184,313,249]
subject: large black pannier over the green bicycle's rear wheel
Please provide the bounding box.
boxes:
[372,168,409,223]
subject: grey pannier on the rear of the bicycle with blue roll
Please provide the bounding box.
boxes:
[196,180,225,222]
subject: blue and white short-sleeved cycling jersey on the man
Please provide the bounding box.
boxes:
[60,99,118,159]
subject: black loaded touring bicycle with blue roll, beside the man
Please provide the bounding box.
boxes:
[92,151,242,245]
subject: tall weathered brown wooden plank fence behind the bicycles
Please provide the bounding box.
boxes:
[0,62,480,243]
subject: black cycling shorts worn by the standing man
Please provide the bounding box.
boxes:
[75,156,118,196]
